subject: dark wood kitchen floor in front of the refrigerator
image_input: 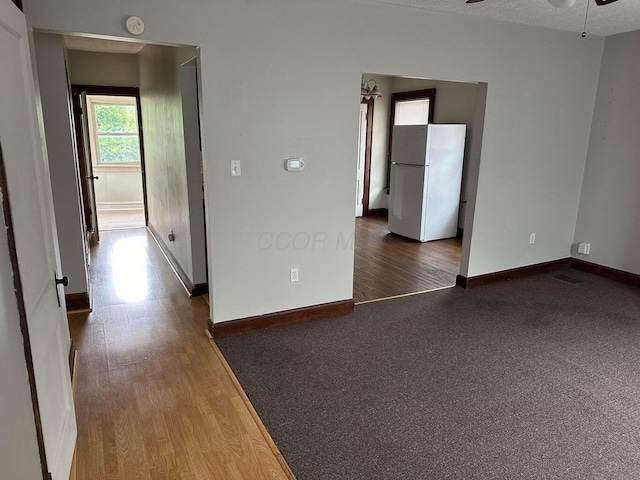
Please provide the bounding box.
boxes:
[353,215,462,303]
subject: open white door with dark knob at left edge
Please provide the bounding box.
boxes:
[0,0,76,480]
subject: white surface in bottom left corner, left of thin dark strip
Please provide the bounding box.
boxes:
[0,192,42,480]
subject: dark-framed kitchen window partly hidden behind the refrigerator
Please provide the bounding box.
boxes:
[387,88,436,189]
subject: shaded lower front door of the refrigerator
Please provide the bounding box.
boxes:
[389,164,428,241]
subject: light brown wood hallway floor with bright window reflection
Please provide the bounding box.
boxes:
[69,229,294,480]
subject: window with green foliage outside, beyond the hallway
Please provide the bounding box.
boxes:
[87,95,140,166]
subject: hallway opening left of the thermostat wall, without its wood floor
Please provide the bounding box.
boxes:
[64,35,208,295]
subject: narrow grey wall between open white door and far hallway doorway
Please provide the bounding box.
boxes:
[34,32,88,293]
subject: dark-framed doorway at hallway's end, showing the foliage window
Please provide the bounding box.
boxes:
[71,85,148,244]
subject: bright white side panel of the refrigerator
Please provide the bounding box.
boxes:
[422,125,466,241]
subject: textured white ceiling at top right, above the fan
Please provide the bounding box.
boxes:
[370,0,640,37]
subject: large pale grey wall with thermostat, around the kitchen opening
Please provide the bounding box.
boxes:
[27,0,603,322]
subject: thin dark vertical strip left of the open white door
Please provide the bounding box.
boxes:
[0,144,51,480]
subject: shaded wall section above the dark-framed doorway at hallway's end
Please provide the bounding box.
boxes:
[67,50,139,87]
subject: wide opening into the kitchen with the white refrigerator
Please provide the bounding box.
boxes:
[353,73,484,304]
